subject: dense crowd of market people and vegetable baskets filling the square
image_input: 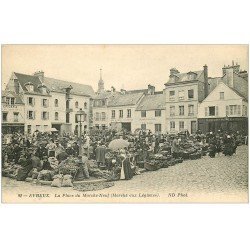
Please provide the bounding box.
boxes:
[2,130,247,186]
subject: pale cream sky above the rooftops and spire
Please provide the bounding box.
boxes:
[2,45,248,91]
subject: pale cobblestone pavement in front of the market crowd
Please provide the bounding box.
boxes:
[2,146,248,202]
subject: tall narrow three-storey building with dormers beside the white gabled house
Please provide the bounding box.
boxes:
[164,65,208,134]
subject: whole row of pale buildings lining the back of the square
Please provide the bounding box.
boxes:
[2,62,248,133]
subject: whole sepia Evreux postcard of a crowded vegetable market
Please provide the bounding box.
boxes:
[1,45,249,203]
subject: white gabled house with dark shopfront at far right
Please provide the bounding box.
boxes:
[198,82,248,133]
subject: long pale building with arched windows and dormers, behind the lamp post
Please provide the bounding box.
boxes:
[3,71,94,133]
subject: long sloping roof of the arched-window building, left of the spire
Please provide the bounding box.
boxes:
[44,77,95,96]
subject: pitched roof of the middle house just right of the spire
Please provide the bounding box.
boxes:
[108,92,143,107]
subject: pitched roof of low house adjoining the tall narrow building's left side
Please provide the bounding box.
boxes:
[136,94,166,111]
